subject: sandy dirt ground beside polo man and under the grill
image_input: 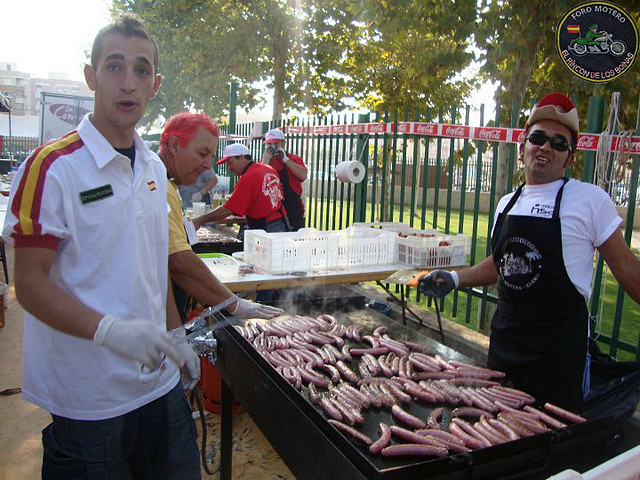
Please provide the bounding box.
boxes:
[0,246,294,480]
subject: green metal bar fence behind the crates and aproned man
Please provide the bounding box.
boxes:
[219,94,640,359]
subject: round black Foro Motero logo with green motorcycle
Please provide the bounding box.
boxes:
[556,2,639,83]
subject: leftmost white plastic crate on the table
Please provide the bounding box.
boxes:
[244,228,338,273]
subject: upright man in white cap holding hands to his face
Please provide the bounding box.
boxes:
[261,128,307,231]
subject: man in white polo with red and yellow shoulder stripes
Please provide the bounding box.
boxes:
[3,15,200,479]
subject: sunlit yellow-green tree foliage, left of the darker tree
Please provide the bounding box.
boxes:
[114,0,475,125]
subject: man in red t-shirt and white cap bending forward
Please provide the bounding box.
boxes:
[193,143,290,238]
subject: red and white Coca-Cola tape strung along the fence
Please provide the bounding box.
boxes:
[285,122,640,154]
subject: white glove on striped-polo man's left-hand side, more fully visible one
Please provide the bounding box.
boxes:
[93,315,184,371]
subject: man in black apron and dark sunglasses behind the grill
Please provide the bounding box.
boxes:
[419,93,640,411]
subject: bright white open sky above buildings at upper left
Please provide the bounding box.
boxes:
[0,0,111,81]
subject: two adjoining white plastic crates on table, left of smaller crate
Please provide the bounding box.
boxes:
[244,228,397,273]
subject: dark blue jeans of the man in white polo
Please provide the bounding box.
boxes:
[42,382,201,480]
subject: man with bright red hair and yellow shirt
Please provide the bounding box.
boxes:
[158,113,282,321]
